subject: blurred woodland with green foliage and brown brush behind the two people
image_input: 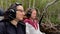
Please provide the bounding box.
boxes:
[0,0,60,34]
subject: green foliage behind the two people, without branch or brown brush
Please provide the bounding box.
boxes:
[0,0,60,24]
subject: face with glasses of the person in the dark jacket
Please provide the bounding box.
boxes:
[16,5,25,20]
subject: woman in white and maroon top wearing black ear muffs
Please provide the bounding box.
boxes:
[24,8,42,34]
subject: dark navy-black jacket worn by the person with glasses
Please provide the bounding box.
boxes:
[0,21,26,34]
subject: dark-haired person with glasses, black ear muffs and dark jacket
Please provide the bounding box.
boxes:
[0,3,26,34]
